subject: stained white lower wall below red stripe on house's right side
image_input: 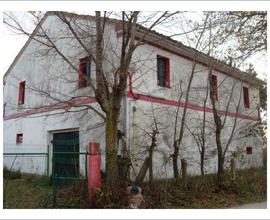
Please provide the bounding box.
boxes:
[129,99,263,179]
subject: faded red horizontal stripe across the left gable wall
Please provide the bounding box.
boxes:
[4,98,96,120]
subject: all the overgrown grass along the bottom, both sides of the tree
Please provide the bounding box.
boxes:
[4,169,267,209]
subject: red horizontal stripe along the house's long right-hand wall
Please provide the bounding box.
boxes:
[128,92,259,121]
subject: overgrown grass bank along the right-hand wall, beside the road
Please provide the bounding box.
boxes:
[140,169,267,209]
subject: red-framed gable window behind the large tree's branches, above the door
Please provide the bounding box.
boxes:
[79,57,91,88]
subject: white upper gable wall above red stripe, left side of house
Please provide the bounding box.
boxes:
[4,15,119,115]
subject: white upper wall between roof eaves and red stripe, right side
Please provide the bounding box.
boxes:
[130,44,259,117]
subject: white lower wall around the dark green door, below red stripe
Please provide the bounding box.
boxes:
[3,103,105,175]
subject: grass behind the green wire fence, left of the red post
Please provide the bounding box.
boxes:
[3,169,88,209]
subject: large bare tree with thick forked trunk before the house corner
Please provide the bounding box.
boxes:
[4,11,177,189]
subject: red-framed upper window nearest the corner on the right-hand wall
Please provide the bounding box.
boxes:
[157,55,170,88]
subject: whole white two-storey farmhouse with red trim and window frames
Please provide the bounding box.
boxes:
[3,12,262,178]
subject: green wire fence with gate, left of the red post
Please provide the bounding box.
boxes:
[3,144,89,208]
